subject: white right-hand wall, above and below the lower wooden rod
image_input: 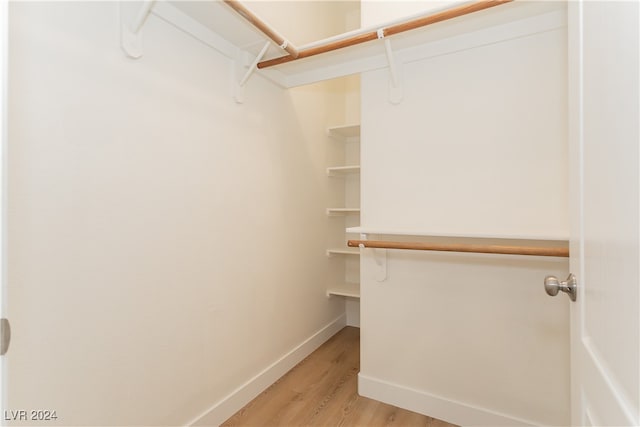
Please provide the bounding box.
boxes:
[359,2,569,425]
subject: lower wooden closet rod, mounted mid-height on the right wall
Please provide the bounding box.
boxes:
[347,240,569,258]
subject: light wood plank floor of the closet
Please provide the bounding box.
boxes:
[222,327,454,427]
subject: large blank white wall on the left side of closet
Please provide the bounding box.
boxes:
[7,2,344,425]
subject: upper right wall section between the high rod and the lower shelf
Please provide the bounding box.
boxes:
[362,28,569,238]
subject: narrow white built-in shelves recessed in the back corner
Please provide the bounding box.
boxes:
[327,125,360,298]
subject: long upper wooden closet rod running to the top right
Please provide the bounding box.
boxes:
[258,0,513,68]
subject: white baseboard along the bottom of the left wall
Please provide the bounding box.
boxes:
[187,314,347,426]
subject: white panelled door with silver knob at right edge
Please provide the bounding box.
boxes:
[569,1,640,426]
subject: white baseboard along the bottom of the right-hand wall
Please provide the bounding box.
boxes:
[358,374,538,426]
